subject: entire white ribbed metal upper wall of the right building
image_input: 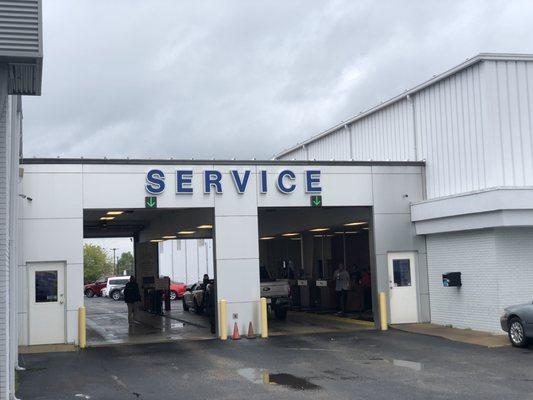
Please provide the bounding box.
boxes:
[281,60,533,198]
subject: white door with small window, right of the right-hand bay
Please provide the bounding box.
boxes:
[388,252,418,324]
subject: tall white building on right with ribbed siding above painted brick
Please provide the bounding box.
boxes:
[275,54,533,332]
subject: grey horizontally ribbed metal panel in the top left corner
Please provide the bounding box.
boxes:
[0,0,42,56]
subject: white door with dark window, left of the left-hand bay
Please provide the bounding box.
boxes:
[28,263,65,344]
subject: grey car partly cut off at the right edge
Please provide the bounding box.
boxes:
[500,302,533,347]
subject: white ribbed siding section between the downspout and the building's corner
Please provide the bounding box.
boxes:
[414,64,486,198]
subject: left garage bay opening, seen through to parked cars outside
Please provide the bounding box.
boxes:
[84,208,216,346]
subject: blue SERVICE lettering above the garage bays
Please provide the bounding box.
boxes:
[145,169,322,195]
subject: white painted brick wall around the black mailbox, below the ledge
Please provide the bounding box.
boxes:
[427,228,533,333]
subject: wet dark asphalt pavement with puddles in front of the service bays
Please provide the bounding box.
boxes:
[18,330,533,400]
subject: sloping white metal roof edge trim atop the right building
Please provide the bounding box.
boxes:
[273,53,533,159]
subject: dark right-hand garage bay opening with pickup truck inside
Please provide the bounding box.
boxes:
[259,207,374,333]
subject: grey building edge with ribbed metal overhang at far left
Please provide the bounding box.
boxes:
[0,0,42,399]
